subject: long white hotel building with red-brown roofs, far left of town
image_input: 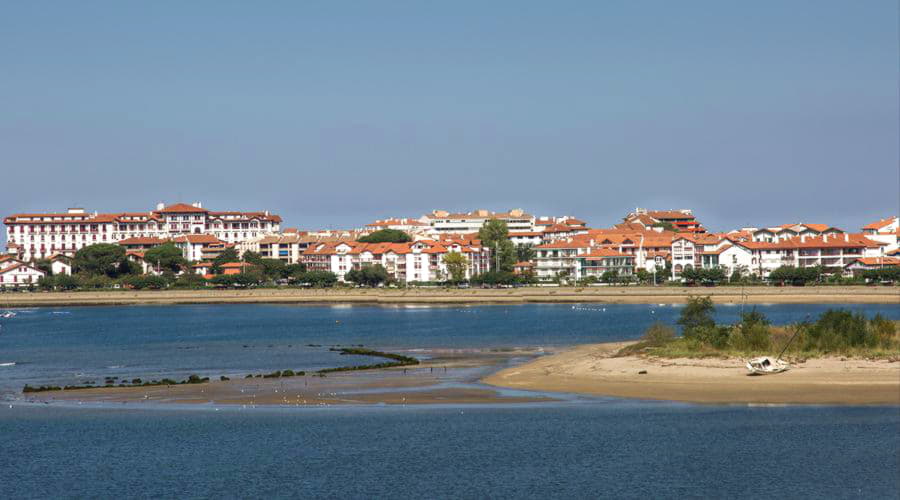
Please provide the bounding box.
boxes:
[3,202,281,261]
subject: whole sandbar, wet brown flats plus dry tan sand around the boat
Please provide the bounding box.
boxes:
[20,341,900,407]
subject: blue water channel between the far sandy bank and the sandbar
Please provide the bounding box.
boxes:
[0,304,900,399]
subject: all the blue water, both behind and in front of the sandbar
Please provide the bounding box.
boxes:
[0,305,900,498]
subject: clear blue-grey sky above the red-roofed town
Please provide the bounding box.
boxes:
[0,0,900,230]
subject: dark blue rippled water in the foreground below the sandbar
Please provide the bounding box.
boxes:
[0,402,900,498]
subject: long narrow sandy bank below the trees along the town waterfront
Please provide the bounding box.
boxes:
[0,286,900,307]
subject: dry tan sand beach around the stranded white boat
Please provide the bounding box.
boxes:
[483,343,900,405]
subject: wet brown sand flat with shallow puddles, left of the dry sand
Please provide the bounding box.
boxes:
[26,349,552,406]
